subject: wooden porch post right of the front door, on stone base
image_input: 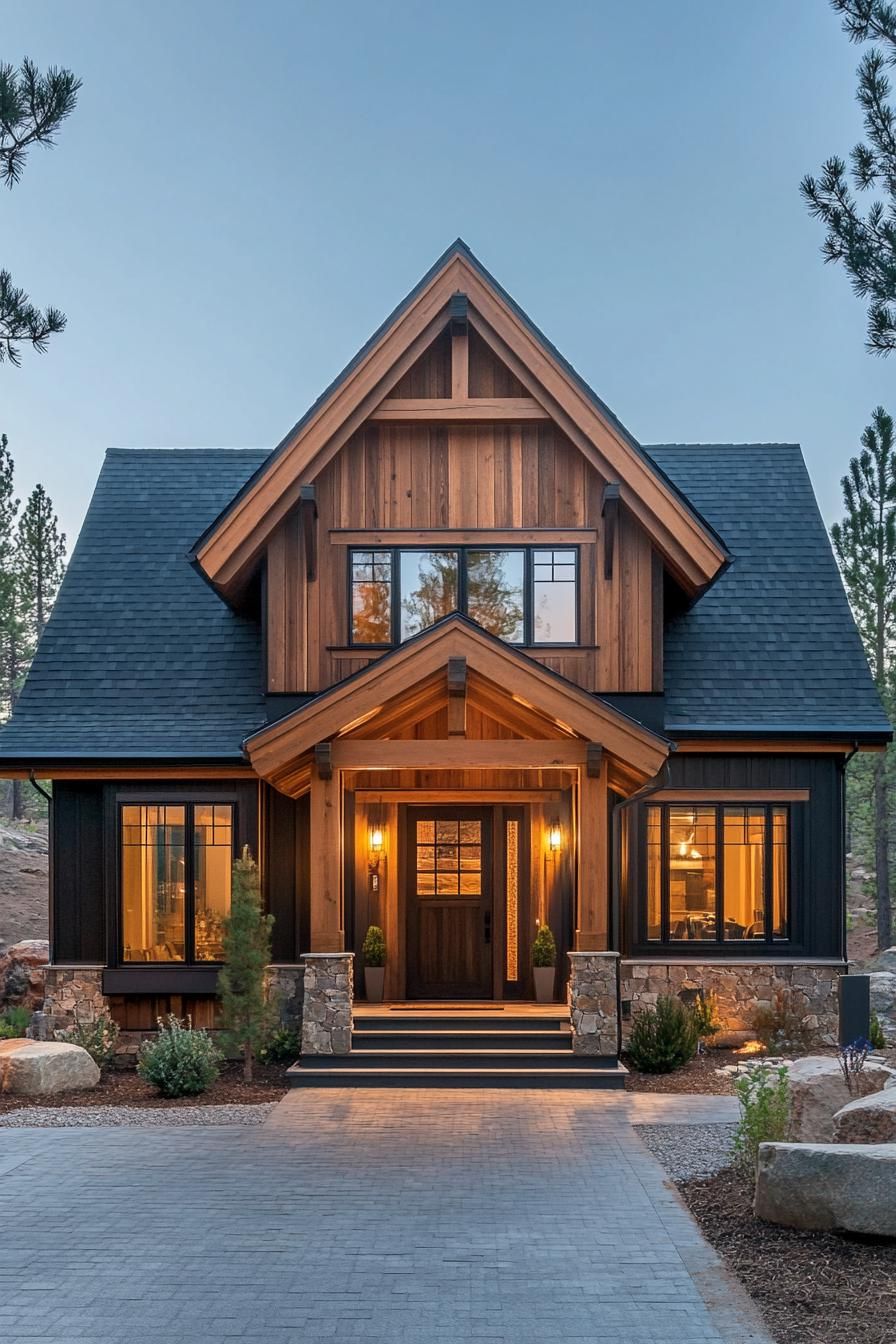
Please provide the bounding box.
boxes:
[575,750,610,952]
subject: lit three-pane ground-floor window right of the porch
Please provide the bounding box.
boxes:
[642,802,790,943]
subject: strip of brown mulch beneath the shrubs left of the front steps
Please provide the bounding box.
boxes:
[0,1063,286,1114]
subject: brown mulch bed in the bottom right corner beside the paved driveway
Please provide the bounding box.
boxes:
[678,1169,896,1344]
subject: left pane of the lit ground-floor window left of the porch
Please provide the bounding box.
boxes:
[121,805,185,961]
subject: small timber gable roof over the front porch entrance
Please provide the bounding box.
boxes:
[243,614,673,796]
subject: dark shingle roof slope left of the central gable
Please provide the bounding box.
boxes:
[0,449,267,758]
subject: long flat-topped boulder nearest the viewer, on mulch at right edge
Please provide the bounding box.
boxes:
[754,1144,896,1236]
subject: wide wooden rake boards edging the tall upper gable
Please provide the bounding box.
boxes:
[193,239,727,594]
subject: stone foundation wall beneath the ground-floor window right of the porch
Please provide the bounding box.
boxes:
[621,961,842,1046]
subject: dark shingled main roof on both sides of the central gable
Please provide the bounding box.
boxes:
[0,445,888,762]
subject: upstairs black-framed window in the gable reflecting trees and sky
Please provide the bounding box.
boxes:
[349,546,579,646]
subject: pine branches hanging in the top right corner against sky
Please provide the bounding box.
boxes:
[799,0,896,355]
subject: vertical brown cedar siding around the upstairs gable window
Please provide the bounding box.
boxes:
[266,333,662,692]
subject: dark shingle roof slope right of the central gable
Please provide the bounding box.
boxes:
[645,444,888,738]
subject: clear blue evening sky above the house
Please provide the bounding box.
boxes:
[0,0,896,548]
